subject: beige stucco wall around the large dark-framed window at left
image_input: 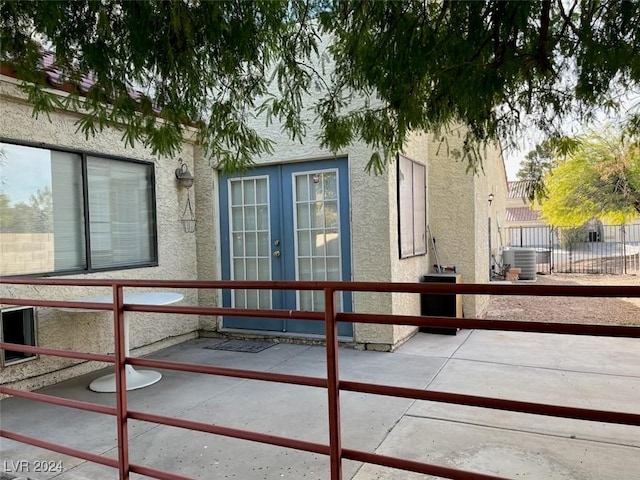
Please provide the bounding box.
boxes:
[0,76,200,389]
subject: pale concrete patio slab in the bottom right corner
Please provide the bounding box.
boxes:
[353,417,640,480]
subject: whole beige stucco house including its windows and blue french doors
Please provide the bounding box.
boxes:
[0,62,507,389]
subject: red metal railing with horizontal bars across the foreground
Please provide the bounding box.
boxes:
[0,278,640,480]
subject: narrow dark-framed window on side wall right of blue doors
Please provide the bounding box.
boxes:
[398,155,427,258]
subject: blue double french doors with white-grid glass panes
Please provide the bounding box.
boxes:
[219,159,353,337]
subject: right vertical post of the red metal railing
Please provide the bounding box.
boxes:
[324,288,342,480]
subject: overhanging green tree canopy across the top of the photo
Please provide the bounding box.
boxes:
[0,0,640,171]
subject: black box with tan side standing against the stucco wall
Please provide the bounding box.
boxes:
[420,273,462,335]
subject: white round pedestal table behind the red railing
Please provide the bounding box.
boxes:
[59,292,184,393]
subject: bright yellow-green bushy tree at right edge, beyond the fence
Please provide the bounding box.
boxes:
[540,132,640,226]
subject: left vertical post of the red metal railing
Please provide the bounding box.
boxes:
[113,284,129,480]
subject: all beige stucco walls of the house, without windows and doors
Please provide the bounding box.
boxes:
[0,47,506,389]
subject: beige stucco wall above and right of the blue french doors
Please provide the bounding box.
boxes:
[238,111,506,350]
